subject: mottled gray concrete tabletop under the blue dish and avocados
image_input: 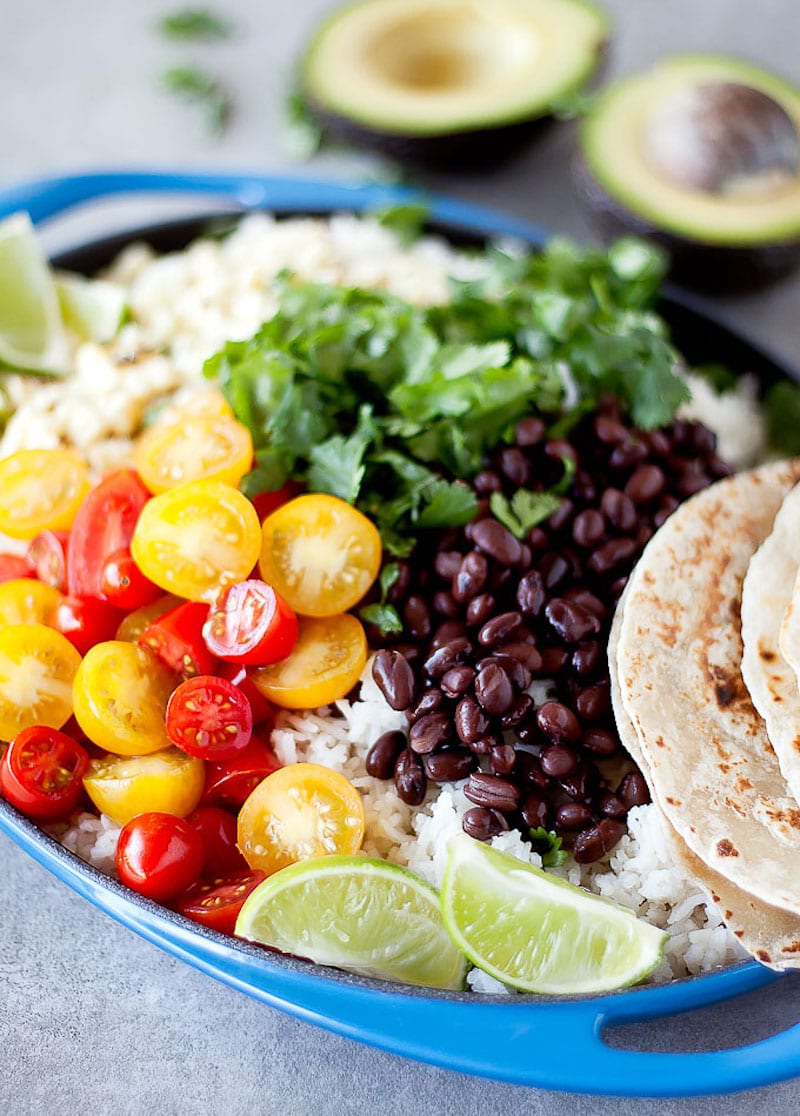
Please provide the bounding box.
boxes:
[0,0,800,1116]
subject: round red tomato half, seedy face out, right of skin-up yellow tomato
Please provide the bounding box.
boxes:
[166,674,253,760]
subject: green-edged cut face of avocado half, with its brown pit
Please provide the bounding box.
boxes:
[580,56,800,247]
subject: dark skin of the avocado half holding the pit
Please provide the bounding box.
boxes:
[574,156,800,294]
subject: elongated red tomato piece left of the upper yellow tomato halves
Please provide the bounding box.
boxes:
[67,469,150,597]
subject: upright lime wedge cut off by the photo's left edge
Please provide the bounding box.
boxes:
[0,213,69,375]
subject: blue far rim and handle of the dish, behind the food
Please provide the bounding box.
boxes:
[0,171,547,243]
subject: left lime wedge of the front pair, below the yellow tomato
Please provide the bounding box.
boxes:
[235,856,466,989]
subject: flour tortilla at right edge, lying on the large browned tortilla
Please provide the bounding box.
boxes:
[742,487,800,800]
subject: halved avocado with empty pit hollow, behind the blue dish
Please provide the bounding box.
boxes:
[300,0,608,165]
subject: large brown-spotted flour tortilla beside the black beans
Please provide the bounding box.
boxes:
[617,461,800,913]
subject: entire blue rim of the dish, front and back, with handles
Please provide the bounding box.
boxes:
[0,172,800,1096]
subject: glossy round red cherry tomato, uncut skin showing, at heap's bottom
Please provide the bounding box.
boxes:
[114,812,205,903]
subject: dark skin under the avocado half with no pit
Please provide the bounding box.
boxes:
[305,97,555,172]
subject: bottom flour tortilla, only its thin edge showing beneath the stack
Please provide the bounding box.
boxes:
[608,589,800,971]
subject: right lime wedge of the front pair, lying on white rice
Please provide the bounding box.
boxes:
[442,835,666,995]
